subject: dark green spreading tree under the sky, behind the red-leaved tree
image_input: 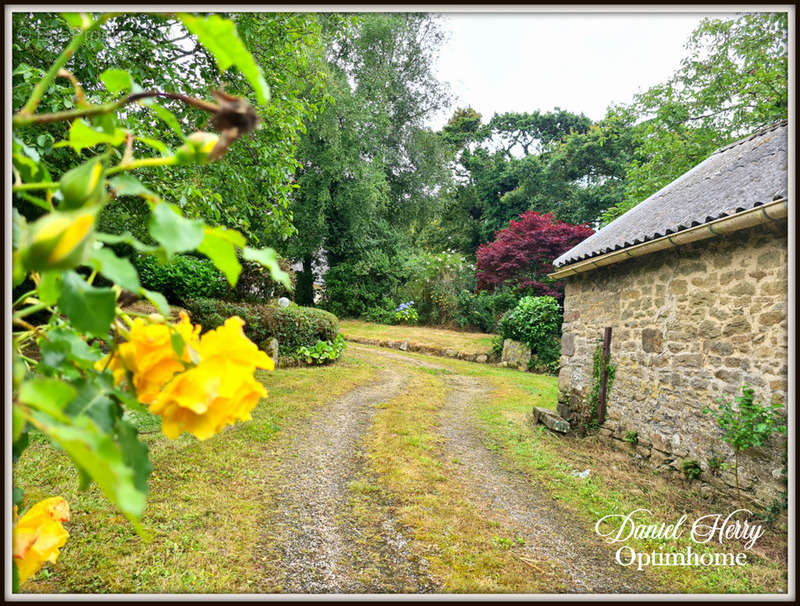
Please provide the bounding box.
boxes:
[426,108,612,249]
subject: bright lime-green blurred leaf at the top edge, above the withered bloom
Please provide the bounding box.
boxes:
[178,13,269,105]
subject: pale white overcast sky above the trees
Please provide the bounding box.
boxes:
[430,13,732,129]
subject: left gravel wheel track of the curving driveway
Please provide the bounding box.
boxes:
[264,369,433,594]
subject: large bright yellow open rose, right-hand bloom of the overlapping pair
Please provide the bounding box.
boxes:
[150,316,274,440]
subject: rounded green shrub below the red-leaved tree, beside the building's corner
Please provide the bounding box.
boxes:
[497,297,562,372]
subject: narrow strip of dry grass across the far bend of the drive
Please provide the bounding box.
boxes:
[339,320,494,355]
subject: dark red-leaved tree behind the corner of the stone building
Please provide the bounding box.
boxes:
[477,210,594,301]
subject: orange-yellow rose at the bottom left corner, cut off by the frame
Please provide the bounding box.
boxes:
[12,497,69,583]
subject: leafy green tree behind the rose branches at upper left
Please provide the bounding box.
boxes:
[12,13,325,246]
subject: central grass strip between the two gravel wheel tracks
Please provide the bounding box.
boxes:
[366,365,563,593]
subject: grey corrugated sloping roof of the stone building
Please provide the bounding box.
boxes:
[553,121,789,268]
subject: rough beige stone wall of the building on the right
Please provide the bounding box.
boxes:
[558,222,788,504]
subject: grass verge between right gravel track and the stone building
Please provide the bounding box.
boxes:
[468,373,787,593]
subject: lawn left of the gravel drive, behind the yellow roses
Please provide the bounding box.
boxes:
[14,358,375,593]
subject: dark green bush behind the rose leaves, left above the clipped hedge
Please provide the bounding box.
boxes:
[131,255,228,305]
